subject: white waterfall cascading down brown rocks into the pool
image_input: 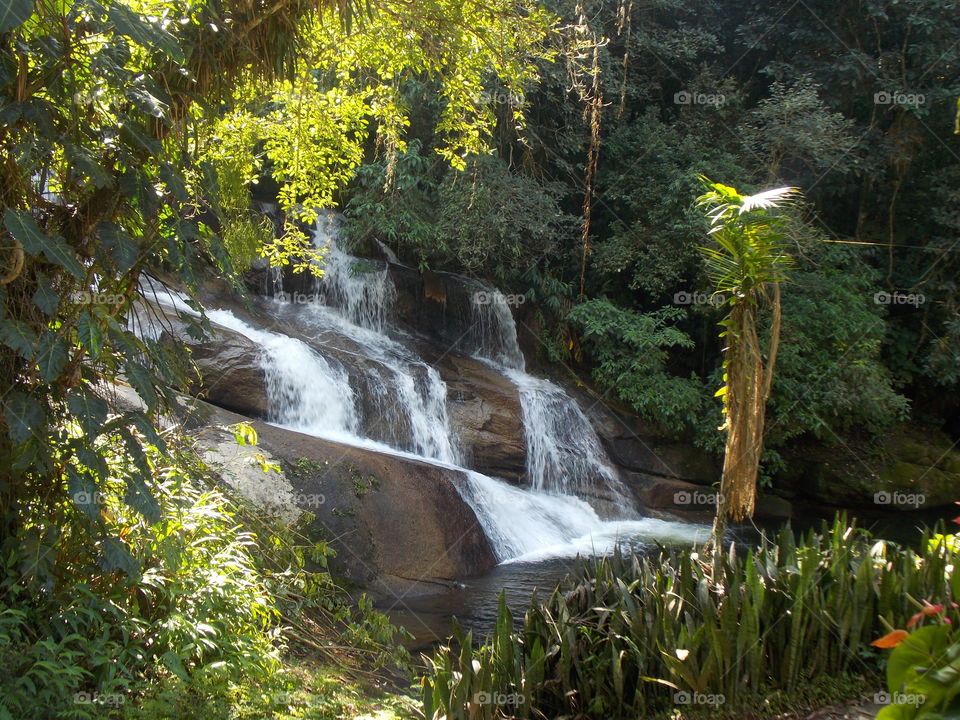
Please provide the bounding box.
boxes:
[148,213,702,562]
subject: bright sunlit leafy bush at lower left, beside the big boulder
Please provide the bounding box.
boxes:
[0,428,401,720]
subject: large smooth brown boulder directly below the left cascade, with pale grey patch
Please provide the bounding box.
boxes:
[198,408,496,595]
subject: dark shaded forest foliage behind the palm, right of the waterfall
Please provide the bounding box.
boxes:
[347,0,960,471]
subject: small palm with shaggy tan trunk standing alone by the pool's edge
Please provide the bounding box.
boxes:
[697,176,800,557]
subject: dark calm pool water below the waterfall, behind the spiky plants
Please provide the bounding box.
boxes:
[386,507,960,650]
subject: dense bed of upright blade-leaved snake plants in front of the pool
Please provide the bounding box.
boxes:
[423,518,955,720]
